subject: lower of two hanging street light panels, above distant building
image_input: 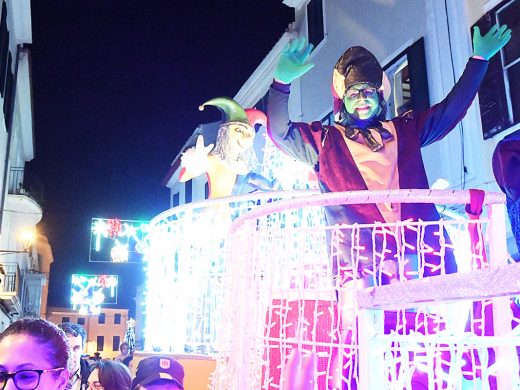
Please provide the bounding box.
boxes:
[71,274,118,314]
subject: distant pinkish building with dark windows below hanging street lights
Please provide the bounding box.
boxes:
[47,308,128,359]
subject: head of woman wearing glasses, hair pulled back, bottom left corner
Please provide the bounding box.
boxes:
[0,318,70,390]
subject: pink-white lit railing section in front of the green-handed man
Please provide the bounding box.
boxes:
[213,190,520,390]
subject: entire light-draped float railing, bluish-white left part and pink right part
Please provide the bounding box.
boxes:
[144,190,520,390]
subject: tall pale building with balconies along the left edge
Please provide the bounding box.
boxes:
[0,0,52,331]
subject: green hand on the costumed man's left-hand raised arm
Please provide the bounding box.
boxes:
[274,37,314,84]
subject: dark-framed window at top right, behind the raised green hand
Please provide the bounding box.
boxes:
[472,0,520,139]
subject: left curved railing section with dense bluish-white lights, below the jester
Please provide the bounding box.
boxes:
[143,191,321,355]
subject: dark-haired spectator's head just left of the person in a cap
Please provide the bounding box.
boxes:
[88,360,132,390]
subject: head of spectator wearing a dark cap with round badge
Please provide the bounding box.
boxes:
[132,356,184,390]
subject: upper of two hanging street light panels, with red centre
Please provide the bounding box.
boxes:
[90,218,148,263]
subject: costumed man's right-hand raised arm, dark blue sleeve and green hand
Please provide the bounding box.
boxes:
[416,25,511,146]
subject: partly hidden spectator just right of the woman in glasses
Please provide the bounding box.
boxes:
[58,322,90,390]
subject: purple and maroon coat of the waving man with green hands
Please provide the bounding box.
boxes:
[268,58,488,276]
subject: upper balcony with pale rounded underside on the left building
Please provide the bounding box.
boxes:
[5,167,42,228]
